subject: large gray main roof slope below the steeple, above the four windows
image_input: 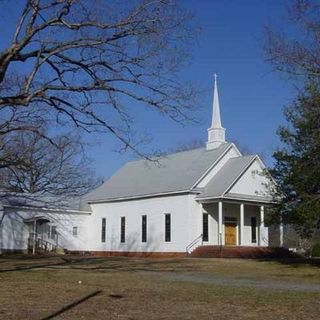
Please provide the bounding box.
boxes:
[86,143,231,202]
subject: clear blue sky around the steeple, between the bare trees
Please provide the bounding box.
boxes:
[0,0,295,178]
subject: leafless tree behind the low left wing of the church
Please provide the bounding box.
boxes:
[0,132,98,197]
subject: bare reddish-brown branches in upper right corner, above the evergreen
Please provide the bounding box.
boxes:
[264,0,320,78]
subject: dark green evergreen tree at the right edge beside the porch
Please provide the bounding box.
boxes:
[271,81,320,238]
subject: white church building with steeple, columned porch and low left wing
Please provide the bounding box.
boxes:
[0,78,273,255]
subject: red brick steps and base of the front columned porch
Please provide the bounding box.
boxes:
[189,246,297,259]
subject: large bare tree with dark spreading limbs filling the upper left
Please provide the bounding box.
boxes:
[0,0,195,159]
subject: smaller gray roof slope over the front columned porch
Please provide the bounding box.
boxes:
[197,155,256,199]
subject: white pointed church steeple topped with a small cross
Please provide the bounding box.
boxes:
[207,74,226,150]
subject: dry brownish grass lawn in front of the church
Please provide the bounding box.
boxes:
[0,256,320,319]
